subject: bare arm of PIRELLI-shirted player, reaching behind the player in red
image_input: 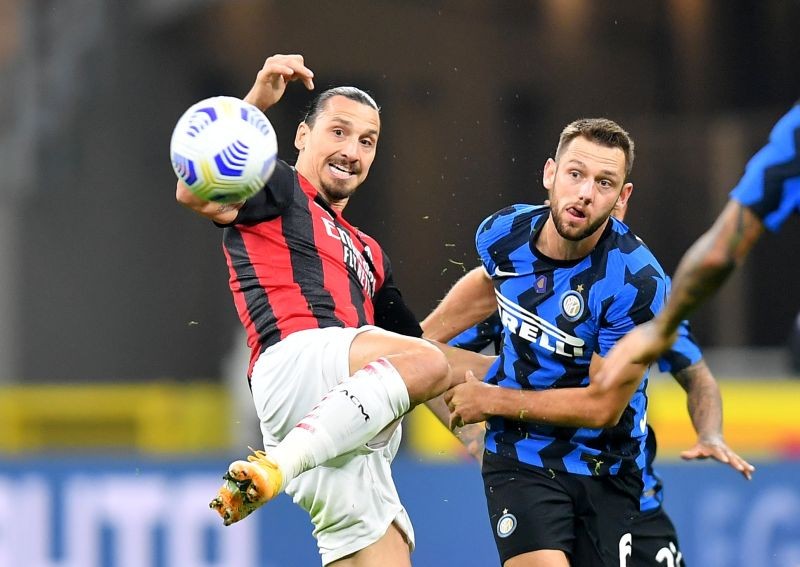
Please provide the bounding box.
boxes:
[421,267,497,342]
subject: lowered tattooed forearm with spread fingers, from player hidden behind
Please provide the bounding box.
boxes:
[673,360,755,480]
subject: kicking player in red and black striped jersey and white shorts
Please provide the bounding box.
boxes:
[176,55,488,567]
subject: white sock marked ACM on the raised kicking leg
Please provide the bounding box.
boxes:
[269,358,411,489]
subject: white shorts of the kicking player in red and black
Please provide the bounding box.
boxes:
[251,326,414,565]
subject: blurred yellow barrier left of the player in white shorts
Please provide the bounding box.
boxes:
[0,384,231,454]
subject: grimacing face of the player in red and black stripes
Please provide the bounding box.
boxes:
[294,96,381,204]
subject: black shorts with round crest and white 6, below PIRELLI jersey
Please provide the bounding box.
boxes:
[482,451,643,567]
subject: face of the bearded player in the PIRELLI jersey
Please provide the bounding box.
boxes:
[543,136,633,241]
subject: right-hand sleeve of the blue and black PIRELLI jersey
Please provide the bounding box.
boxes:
[597,266,667,356]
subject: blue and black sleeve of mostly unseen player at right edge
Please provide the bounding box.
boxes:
[730,103,800,232]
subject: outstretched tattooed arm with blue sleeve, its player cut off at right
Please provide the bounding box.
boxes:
[600,104,800,383]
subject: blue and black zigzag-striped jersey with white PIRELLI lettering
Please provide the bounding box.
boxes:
[476,205,668,475]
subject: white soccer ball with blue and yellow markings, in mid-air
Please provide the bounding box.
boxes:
[170,96,278,203]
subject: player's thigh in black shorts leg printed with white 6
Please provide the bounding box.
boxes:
[570,474,642,567]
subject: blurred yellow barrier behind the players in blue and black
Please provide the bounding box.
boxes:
[406,376,800,460]
